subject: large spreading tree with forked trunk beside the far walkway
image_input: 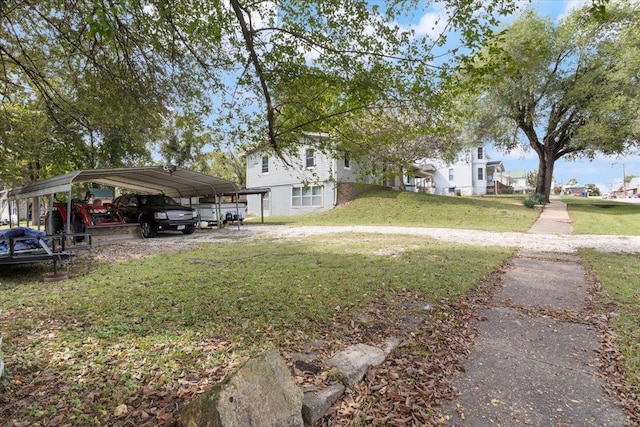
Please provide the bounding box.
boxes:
[460,2,640,201]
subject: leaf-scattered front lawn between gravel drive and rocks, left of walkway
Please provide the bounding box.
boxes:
[0,235,512,425]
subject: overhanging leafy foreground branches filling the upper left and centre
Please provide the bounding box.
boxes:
[0,0,515,184]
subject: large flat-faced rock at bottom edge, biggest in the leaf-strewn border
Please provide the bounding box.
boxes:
[180,351,304,427]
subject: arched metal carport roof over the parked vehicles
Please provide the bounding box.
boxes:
[7,166,238,199]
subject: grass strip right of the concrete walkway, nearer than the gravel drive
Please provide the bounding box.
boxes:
[581,250,640,390]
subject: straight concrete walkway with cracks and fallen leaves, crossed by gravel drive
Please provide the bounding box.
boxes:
[443,199,628,427]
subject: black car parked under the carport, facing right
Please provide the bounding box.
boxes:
[113,194,198,237]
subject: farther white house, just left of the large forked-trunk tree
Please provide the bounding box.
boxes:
[405,147,498,196]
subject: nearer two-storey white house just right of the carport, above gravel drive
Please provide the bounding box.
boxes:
[246,133,373,216]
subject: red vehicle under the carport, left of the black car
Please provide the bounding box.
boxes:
[44,199,125,234]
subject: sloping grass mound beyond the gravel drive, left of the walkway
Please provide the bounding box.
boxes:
[258,191,539,232]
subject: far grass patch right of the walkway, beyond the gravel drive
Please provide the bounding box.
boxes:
[563,197,640,236]
